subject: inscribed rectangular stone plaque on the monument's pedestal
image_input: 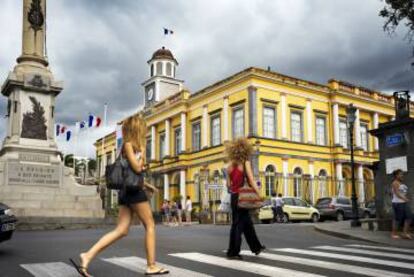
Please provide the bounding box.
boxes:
[7,163,60,187]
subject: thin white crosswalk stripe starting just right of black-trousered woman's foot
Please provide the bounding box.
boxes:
[271,248,414,269]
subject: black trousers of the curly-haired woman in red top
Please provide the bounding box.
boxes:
[227,193,262,256]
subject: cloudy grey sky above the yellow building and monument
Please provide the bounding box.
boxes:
[0,0,414,156]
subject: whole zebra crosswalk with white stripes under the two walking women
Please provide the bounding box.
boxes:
[20,244,414,277]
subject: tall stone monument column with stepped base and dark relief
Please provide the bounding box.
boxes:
[0,0,104,226]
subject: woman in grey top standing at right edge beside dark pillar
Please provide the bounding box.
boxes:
[391,169,412,239]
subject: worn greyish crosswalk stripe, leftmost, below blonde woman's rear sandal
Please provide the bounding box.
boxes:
[20,262,79,277]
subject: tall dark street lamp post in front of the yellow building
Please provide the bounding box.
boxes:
[346,104,361,227]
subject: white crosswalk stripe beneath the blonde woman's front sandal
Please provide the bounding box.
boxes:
[102,256,211,277]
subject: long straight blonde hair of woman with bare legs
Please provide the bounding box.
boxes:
[122,114,147,151]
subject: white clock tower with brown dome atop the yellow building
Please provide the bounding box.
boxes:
[142,46,184,107]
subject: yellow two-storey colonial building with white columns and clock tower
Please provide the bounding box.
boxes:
[95,48,414,209]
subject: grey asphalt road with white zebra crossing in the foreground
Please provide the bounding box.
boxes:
[0,223,414,277]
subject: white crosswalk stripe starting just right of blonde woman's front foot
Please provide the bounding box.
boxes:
[169,252,323,277]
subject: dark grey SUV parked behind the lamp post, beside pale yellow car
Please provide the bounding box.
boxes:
[315,197,370,221]
